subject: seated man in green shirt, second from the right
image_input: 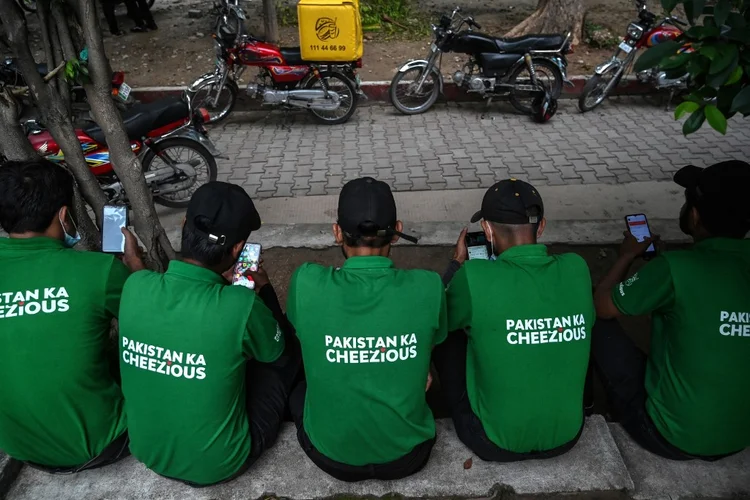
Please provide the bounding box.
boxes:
[433,179,594,462]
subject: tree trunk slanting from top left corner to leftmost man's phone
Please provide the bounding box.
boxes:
[0,0,107,226]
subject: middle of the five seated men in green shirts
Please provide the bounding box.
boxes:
[287,177,447,481]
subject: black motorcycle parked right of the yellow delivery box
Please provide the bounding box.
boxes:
[390,7,572,115]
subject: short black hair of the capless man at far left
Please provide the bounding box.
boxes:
[0,158,73,233]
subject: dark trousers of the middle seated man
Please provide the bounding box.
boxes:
[289,382,435,482]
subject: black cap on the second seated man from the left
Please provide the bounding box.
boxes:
[185,181,260,246]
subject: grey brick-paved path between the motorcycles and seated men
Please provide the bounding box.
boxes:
[211,98,750,198]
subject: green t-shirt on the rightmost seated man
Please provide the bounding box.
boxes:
[612,238,750,455]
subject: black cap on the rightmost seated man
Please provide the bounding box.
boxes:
[674,160,750,222]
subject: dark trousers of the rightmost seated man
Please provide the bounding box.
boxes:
[591,319,728,461]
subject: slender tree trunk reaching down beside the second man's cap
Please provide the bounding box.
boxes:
[69,0,175,270]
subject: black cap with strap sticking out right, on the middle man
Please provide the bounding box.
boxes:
[338,177,418,243]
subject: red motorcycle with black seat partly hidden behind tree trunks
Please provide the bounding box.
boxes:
[24,95,219,208]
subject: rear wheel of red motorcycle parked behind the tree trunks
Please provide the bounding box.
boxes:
[143,137,217,208]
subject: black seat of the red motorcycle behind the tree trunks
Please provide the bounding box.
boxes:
[83,96,188,144]
